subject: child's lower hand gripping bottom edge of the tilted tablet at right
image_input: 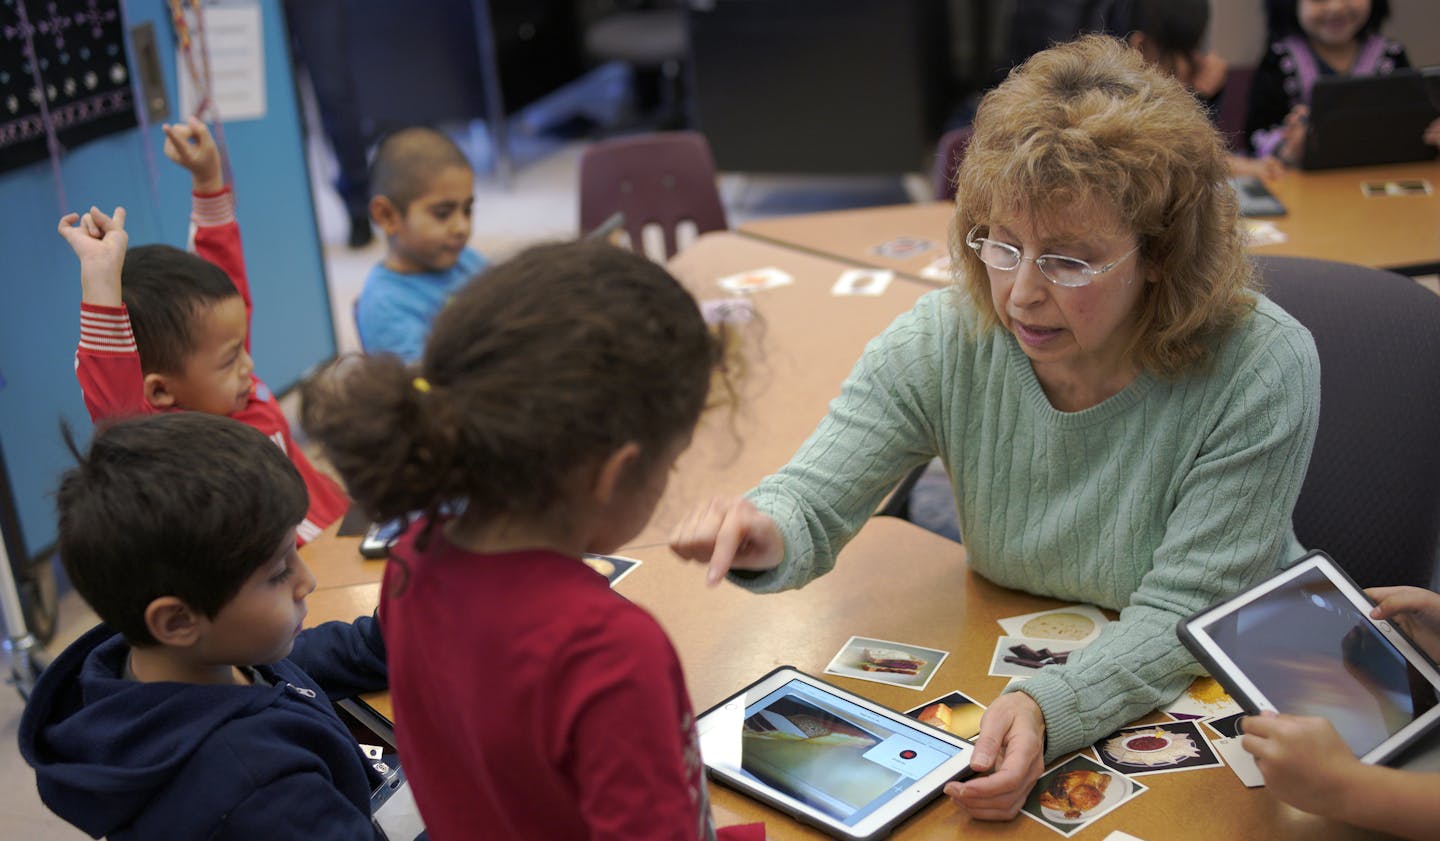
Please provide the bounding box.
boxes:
[1240,711,1364,817]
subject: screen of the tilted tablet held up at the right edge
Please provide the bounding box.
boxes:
[1204,566,1436,756]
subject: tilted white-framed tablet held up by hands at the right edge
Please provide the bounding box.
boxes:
[1176,552,1440,763]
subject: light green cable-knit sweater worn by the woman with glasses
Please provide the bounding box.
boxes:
[732,288,1320,762]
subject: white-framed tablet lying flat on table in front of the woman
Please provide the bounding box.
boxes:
[701,673,971,827]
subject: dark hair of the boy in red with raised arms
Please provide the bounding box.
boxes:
[120,245,240,374]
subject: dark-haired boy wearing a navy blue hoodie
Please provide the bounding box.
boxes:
[20,412,386,841]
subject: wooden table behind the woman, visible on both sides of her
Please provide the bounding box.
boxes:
[739,161,1440,282]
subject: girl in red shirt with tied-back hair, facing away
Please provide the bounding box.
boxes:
[304,242,763,841]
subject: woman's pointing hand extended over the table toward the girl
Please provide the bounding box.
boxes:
[670,497,785,586]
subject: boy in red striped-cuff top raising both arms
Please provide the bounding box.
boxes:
[59,118,348,543]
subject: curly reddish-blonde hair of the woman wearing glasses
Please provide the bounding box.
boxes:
[950,35,1254,377]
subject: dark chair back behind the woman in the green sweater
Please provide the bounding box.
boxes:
[1256,256,1440,588]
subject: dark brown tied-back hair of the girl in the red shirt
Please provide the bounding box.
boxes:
[302,242,720,532]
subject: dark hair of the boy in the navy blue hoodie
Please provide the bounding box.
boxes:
[56,412,310,647]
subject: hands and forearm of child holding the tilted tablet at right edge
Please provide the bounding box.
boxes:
[1241,588,1440,840]
